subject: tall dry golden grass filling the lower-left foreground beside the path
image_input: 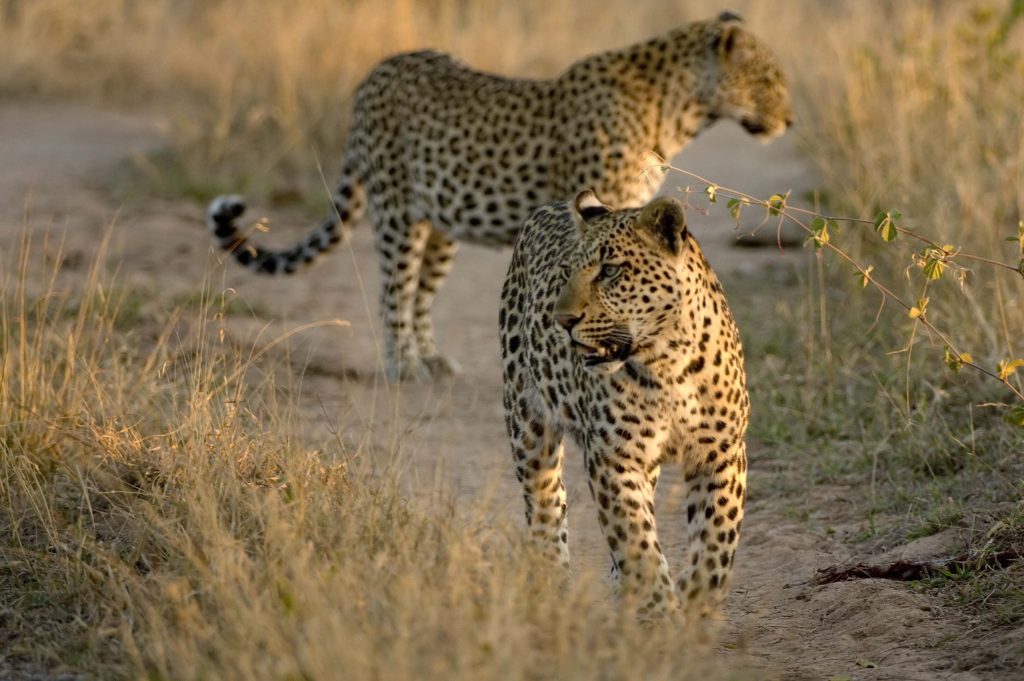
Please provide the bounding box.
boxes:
[0,232,738,680]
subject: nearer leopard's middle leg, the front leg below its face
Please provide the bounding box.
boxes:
[586,444,678,622]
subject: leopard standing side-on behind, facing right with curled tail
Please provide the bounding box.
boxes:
[208,13,791,378]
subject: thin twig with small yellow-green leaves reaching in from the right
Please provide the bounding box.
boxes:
[664,164,1024,426]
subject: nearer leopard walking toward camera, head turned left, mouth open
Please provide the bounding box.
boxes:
[500,191,750,619]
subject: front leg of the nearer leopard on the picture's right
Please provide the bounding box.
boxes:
[677,441,746,615]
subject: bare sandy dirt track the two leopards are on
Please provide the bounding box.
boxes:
[0,100,994,680]
